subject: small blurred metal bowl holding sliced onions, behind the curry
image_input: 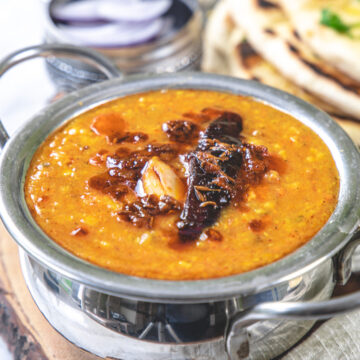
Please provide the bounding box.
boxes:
[44,0,204,90]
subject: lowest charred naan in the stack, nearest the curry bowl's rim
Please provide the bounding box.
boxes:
[202,0,360,146]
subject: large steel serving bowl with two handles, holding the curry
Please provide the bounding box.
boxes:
[0,45,360,360]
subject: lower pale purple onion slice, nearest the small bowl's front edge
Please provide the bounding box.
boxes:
[59,19,164,47]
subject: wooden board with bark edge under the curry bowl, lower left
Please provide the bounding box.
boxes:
[0,223,100,360]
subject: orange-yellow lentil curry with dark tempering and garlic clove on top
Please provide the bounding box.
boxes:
[25,90,339,280]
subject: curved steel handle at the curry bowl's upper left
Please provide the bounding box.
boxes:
[0,44,122,149]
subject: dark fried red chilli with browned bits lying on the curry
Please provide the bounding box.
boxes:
[177,112,268,241]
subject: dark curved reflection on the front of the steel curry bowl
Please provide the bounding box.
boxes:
[81,288,226,343]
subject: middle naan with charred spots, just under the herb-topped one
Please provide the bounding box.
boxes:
[229,0,360,119]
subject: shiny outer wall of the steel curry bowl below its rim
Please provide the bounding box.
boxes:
[21,252,334,360]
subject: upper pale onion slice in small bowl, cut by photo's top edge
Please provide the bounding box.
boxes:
[52,0,173,24]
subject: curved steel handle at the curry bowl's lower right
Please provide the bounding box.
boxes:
[225,229,360,360]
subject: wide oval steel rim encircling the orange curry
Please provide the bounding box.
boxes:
[0,73,360,303]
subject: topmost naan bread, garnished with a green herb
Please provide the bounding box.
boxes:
[280,0,360,81]
